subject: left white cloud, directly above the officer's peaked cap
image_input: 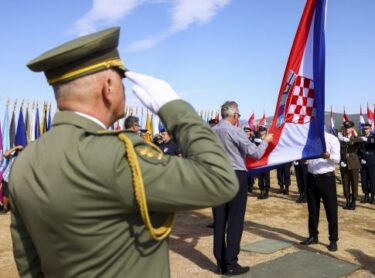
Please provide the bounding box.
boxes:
[72,0,145,35]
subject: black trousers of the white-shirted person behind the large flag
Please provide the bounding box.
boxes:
[306,172,339,241]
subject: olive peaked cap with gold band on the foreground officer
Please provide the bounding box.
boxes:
[27,27,126,85]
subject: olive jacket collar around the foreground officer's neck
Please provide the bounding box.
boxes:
[52,111,105,132]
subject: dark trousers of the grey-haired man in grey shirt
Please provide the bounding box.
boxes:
[213,171,247,265]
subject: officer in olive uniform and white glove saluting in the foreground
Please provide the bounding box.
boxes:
[10,28,238,277]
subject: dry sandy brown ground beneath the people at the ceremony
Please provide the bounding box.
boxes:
[0,171,375,278]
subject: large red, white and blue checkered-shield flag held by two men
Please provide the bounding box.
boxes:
[247,0,326,172]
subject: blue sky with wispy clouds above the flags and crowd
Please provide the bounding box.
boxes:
[0,0,375,119]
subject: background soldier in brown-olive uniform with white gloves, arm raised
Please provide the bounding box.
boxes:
[338,121,362,210]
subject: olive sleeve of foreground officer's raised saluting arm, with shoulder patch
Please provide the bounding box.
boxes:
[117,100,238,212]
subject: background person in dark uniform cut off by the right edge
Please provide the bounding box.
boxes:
[359,123,375,204]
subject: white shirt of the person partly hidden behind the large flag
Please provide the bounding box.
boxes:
[307,132,340,175]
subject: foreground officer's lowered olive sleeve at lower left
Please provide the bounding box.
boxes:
[10,203,44,278]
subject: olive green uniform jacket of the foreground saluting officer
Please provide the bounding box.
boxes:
[10,100,238,277]
